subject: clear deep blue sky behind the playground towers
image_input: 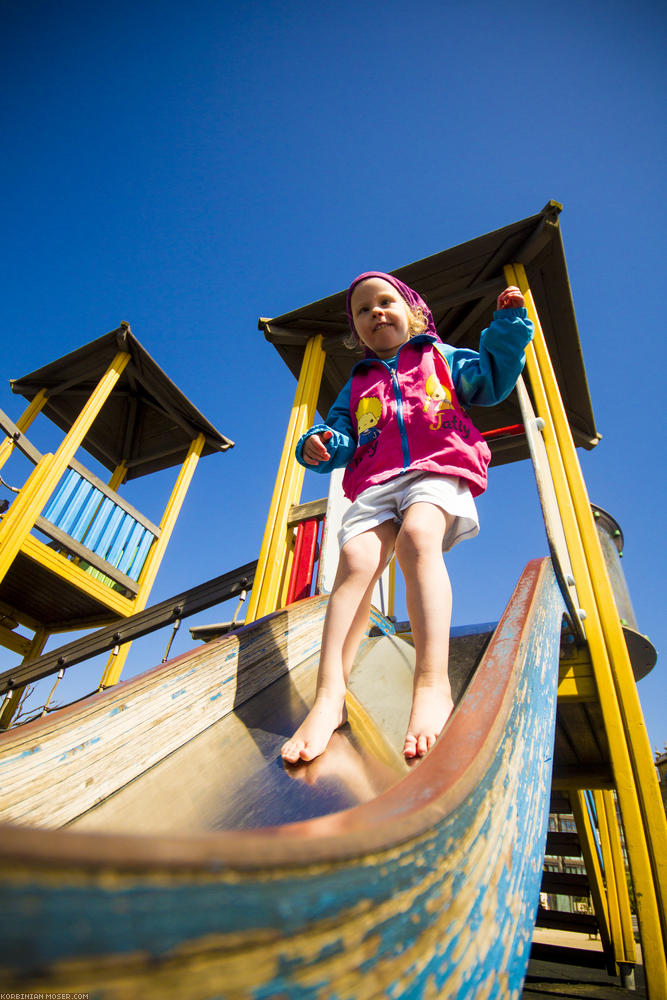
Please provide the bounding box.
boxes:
[0,0,667,748]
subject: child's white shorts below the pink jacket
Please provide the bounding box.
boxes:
[338,472,479,552]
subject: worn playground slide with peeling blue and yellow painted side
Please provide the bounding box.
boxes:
[0,560,563,1000]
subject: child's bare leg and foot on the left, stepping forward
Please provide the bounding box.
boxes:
[280,521,397,764]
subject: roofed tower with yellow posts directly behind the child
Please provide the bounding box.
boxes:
[253,202,667,997]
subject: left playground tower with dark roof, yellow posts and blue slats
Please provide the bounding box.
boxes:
[0,323,233,728]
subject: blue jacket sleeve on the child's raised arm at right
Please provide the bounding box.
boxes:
[443,307,533,407]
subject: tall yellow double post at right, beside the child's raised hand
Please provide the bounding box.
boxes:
[505,265,667,996]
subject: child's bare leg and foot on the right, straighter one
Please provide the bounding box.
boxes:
[396,502,454,757]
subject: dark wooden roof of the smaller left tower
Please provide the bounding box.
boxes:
[10,323,234,480]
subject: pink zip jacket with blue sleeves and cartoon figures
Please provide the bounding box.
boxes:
[296,309,533,500]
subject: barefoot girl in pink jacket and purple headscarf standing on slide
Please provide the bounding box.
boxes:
[281,271,533,763]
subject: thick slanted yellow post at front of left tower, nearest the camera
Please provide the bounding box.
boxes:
[0,351,130,580]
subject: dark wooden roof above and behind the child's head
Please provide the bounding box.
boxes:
[258,201,600,464]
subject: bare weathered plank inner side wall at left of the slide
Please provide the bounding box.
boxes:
[0,598,326,827]
